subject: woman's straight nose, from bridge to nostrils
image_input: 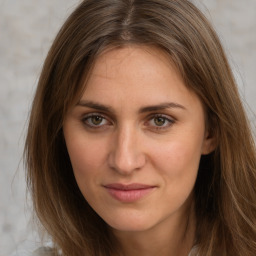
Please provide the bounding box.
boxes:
[108,126,146,175]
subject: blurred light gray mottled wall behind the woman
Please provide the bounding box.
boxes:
[0,0,256,256]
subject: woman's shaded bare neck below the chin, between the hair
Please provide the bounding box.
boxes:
[114,197,196,256]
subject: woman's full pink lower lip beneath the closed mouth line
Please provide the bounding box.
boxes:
[107,187,154,203]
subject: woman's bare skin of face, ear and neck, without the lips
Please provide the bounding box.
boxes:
[63,46,214,256]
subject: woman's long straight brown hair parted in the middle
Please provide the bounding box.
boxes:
[24,0,256,256]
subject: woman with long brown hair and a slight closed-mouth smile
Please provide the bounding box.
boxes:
[25,0,256,256]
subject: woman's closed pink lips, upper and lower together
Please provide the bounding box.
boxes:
[103,183,156,203]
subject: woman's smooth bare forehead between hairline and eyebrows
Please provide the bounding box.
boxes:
[78,46,204,114]
